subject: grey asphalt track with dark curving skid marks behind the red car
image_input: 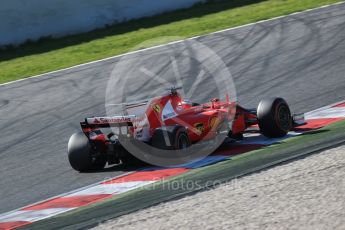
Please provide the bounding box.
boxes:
[0,4,345,213]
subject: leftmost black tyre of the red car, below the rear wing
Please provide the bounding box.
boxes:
[68,132,107,172]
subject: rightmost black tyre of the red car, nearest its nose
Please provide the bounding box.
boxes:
[257,98,292,137]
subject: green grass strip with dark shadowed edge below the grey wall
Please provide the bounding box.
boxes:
[0,0,341,83]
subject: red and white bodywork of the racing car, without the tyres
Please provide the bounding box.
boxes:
[81,92,257,143]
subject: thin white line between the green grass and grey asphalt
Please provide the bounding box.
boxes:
[0,2,345,86]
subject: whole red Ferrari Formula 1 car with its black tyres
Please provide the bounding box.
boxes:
[68,87,304,171]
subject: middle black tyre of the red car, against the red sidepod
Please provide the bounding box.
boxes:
[151,125,191,150]
